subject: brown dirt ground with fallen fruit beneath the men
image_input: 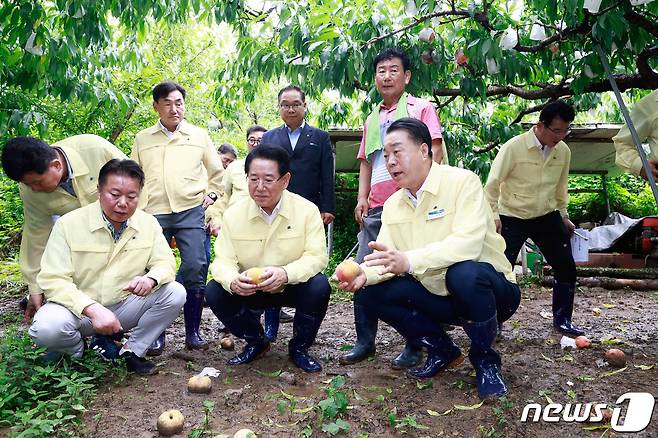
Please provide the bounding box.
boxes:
[2,287,658,438]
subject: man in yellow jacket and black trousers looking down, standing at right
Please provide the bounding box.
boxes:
[484,100,584,336]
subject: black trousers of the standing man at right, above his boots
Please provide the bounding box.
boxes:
[500,211,576,283]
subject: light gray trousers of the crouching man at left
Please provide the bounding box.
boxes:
[29,281,186,358]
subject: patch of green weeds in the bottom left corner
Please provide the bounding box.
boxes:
[0,325,120,437]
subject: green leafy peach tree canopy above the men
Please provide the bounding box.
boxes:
[0,0,658,171]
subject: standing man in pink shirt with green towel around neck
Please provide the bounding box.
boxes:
[339,48,448,369]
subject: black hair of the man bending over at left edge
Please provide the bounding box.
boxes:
[2,137,57,181]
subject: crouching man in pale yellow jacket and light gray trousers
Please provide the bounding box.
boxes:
[29,159,185,375]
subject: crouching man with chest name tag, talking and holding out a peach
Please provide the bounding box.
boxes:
[336,117,521,399]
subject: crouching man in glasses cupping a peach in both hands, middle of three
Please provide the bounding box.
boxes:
[206,145,331,372]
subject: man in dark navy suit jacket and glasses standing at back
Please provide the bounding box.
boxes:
[261,85,336,342]
